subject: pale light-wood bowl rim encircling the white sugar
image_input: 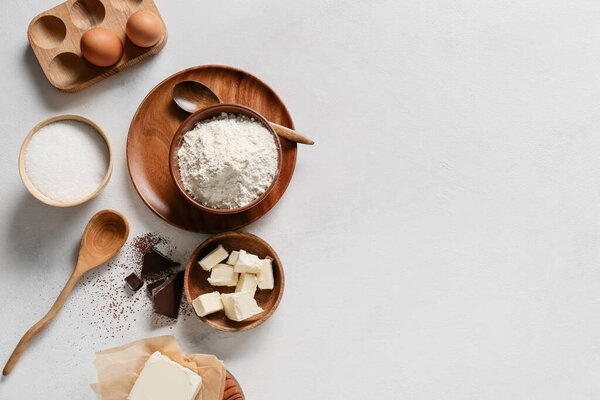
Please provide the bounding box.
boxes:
[19,114,113,207]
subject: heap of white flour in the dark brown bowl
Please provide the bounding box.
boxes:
[177,113,278,209]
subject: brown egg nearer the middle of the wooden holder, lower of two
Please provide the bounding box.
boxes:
[80,28,123,67]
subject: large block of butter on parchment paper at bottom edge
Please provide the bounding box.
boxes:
[127,351,202,400]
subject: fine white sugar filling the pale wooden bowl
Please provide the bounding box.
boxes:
[24,120,109,203]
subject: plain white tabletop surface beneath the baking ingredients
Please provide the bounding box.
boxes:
[0,0,600,400]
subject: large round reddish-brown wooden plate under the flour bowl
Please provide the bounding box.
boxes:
[127,65,297,233]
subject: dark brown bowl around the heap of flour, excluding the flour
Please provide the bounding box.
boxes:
[169,103,283,214]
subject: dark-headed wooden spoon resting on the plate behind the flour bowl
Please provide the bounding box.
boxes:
[173,81,315,144]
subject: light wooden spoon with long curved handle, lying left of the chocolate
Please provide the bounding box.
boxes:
[2,210,129,375]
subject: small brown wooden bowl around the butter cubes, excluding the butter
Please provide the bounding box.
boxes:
[184,232,285,332]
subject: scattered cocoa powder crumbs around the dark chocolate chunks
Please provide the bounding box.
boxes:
[65,233,193,339]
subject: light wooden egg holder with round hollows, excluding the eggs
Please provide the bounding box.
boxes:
[27,0,167,92]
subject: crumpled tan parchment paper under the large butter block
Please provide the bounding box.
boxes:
[90,335,226,400]
